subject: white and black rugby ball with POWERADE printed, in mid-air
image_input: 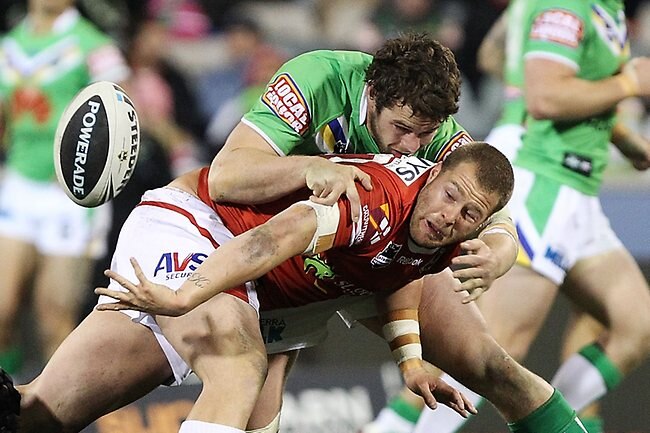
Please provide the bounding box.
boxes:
[54,81,140,207]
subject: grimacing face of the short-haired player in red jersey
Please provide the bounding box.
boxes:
[409,163,499,248]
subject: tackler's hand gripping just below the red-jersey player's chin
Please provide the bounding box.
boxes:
[451,239,499,304]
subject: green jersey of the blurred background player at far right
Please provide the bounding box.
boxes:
[515,0,630,195]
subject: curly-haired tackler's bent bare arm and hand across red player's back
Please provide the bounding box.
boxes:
[209,123,372,221]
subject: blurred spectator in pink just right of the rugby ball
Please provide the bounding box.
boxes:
[120,20,204,176]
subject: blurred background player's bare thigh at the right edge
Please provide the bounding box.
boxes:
[563,248,650,332]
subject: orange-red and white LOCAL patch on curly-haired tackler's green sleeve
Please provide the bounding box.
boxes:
[262,73,311,135]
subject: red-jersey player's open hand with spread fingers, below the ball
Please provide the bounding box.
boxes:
[95,258,186,316]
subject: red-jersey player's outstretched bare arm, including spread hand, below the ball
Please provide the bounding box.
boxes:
[95,204,317,316]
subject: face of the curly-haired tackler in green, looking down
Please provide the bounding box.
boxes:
[366,99,440,156]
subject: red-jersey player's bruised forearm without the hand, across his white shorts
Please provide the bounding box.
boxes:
[176,206,316,312]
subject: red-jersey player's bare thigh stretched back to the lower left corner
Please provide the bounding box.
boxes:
[22,311,172,431]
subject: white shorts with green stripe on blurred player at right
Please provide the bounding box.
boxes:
[508,167,623,285]
